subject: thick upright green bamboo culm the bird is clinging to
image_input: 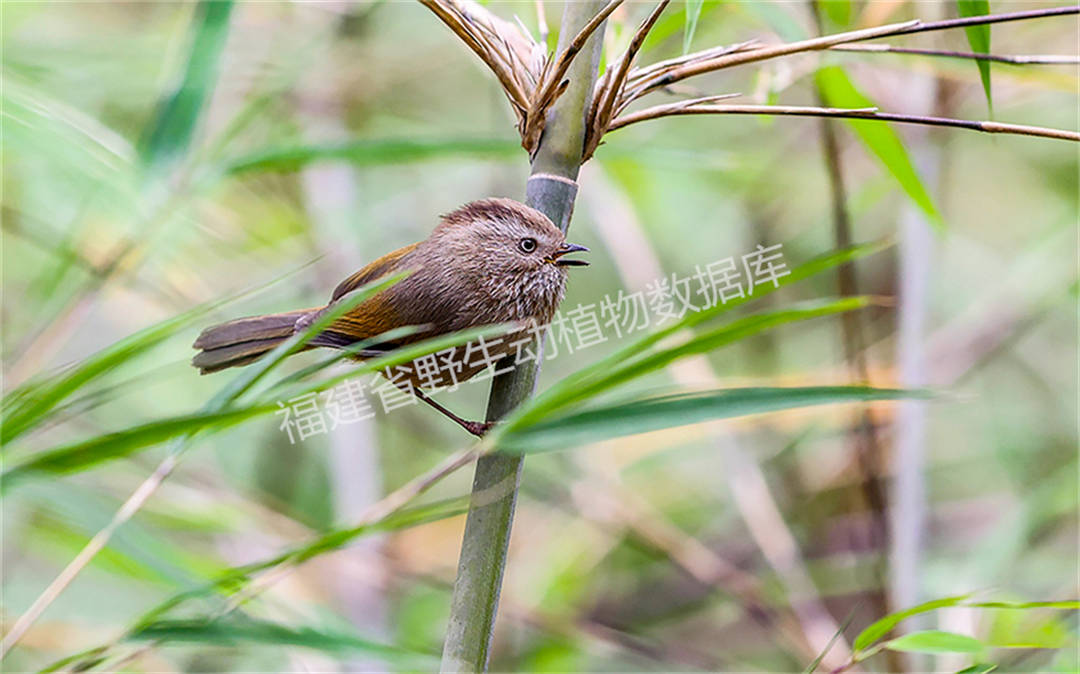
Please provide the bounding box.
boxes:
[442,0,605,672]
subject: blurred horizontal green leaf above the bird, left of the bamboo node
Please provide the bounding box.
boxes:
[225,138,522,174]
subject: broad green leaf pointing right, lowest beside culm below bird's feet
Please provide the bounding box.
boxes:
[498,387,929,451]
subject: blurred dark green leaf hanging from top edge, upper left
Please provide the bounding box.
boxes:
[139,0,232,171]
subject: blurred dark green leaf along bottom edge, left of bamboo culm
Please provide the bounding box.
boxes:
[126,616,434,664]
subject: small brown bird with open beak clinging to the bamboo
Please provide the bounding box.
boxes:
[192,199,589,435]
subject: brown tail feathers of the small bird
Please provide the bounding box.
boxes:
[191,309,318,375]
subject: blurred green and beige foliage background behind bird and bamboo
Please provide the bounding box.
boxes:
[2,0,1080,672]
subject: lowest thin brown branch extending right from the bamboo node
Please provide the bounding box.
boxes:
[608,103,1080,141]
